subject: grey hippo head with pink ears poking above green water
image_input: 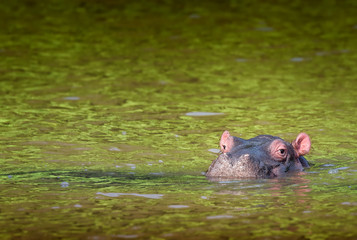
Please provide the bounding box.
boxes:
[206,131,311,178]
